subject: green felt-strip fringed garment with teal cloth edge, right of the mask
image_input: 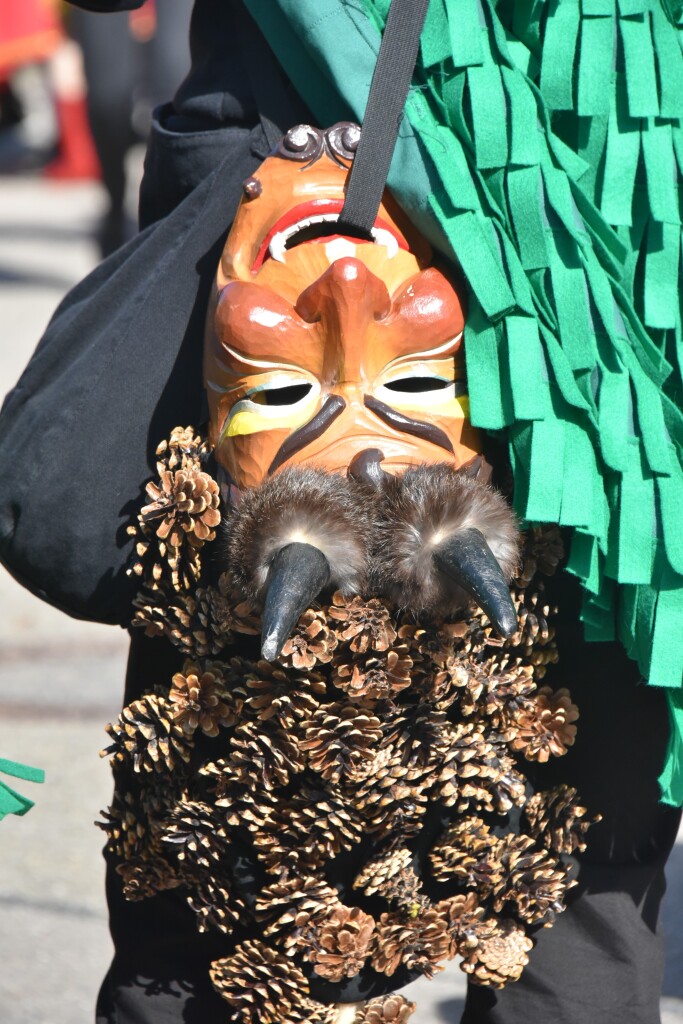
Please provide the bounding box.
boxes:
[248,0,683,804]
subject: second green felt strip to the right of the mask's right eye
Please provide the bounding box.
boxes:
[505,316,550,420]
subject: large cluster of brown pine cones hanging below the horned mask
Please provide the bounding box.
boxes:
[101,428,591,1024]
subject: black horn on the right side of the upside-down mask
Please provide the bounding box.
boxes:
[433,527,517,638]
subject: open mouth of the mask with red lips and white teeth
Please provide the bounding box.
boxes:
[252,199,409,273]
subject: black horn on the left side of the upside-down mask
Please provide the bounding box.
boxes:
[261,542,330,662]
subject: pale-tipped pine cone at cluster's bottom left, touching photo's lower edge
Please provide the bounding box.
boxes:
[210,941,310,1024]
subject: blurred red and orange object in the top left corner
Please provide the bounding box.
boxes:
[0,0,62,79]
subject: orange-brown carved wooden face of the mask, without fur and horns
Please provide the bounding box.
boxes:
[204,124,480,488]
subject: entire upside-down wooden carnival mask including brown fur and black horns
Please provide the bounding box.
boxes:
[204,123,516,656]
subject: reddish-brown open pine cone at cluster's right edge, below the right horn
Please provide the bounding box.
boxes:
[510,686,579,764]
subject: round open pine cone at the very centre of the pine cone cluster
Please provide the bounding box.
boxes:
[299,702,382,785]
